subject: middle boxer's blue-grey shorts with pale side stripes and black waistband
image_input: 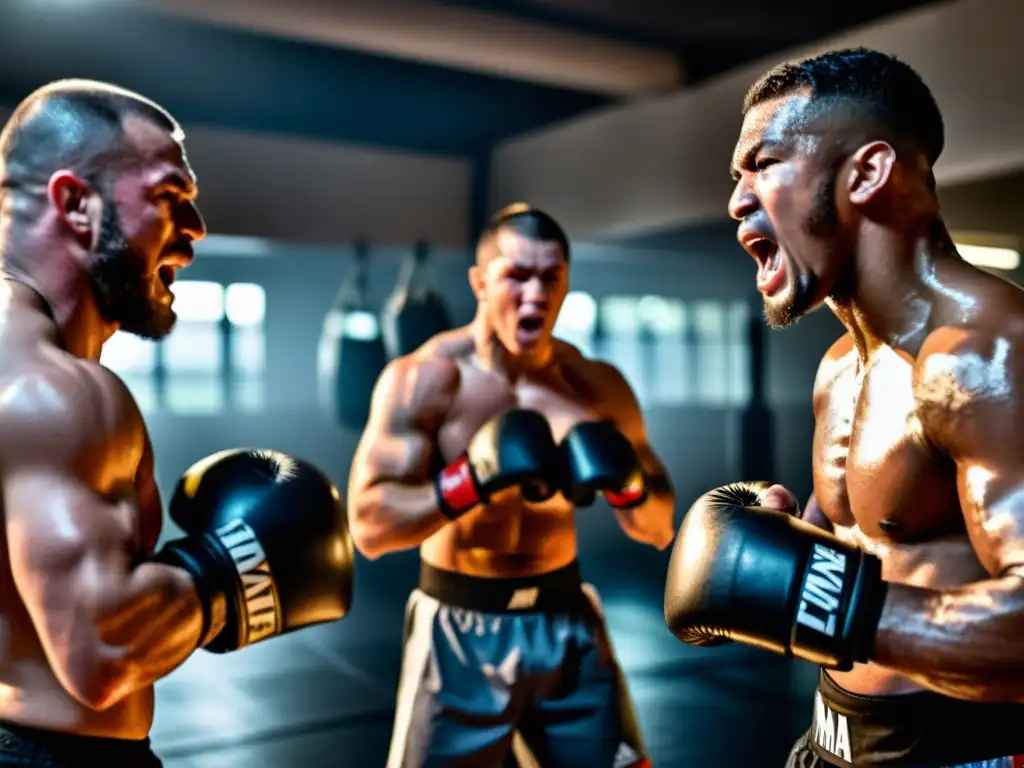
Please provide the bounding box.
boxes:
[387,562,650,768]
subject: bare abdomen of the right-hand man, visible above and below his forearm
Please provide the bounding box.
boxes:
[828,525,989,696]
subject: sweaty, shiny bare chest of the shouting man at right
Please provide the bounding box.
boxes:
[814,349,963,542]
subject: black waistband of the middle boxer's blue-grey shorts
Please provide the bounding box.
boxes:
[420,560,585,613]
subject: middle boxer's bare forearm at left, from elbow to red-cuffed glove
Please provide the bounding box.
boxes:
[351,482,450,559]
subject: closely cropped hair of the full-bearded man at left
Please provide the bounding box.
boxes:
[0,80,182,190]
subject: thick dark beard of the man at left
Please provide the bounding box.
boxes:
[87,205,177,341]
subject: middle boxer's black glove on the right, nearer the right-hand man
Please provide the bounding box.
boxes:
[559,421,647,509]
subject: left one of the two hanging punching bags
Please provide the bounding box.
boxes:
[316,243,387,430]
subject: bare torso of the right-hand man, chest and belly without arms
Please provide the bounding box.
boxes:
[813,337,988,695]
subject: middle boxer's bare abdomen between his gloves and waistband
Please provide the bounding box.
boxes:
[420,492,577,579]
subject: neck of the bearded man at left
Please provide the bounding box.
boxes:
[0,228,117,360]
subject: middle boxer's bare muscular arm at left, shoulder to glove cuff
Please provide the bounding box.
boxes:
[348,357,459,559]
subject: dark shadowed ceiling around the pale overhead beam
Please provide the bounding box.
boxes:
[0,0,926,157]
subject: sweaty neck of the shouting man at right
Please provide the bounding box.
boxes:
[826,219,956,359]
